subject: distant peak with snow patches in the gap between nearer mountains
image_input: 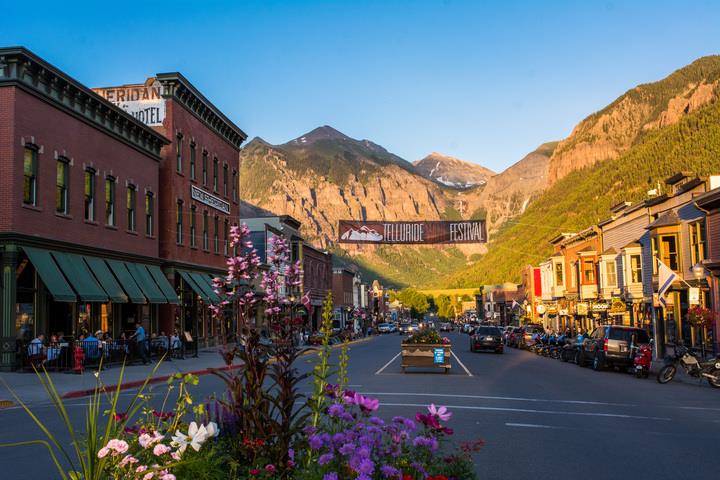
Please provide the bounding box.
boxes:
[413,152,495,189]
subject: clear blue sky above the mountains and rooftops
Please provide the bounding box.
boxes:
[0,0,720,171]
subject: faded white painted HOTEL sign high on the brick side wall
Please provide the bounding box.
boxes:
[94,82,165,127]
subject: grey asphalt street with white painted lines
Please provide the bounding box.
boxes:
[0,333,720,480]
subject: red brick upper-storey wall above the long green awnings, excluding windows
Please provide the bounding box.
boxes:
[0,86,158,256]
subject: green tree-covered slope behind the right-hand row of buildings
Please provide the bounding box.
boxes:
[448,96,720,287]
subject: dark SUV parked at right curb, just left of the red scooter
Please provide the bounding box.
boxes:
[578,325,650,370]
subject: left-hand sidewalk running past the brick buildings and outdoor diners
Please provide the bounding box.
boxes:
[0,337,374,408]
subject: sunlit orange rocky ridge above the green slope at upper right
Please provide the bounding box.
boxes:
[548,55,720,185]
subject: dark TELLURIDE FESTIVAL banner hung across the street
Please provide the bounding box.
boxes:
[338,220,487,245]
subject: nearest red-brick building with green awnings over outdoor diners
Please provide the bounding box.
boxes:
[0,48,177,368]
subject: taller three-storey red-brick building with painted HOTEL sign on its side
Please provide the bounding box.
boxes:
[95,73,247,344]
